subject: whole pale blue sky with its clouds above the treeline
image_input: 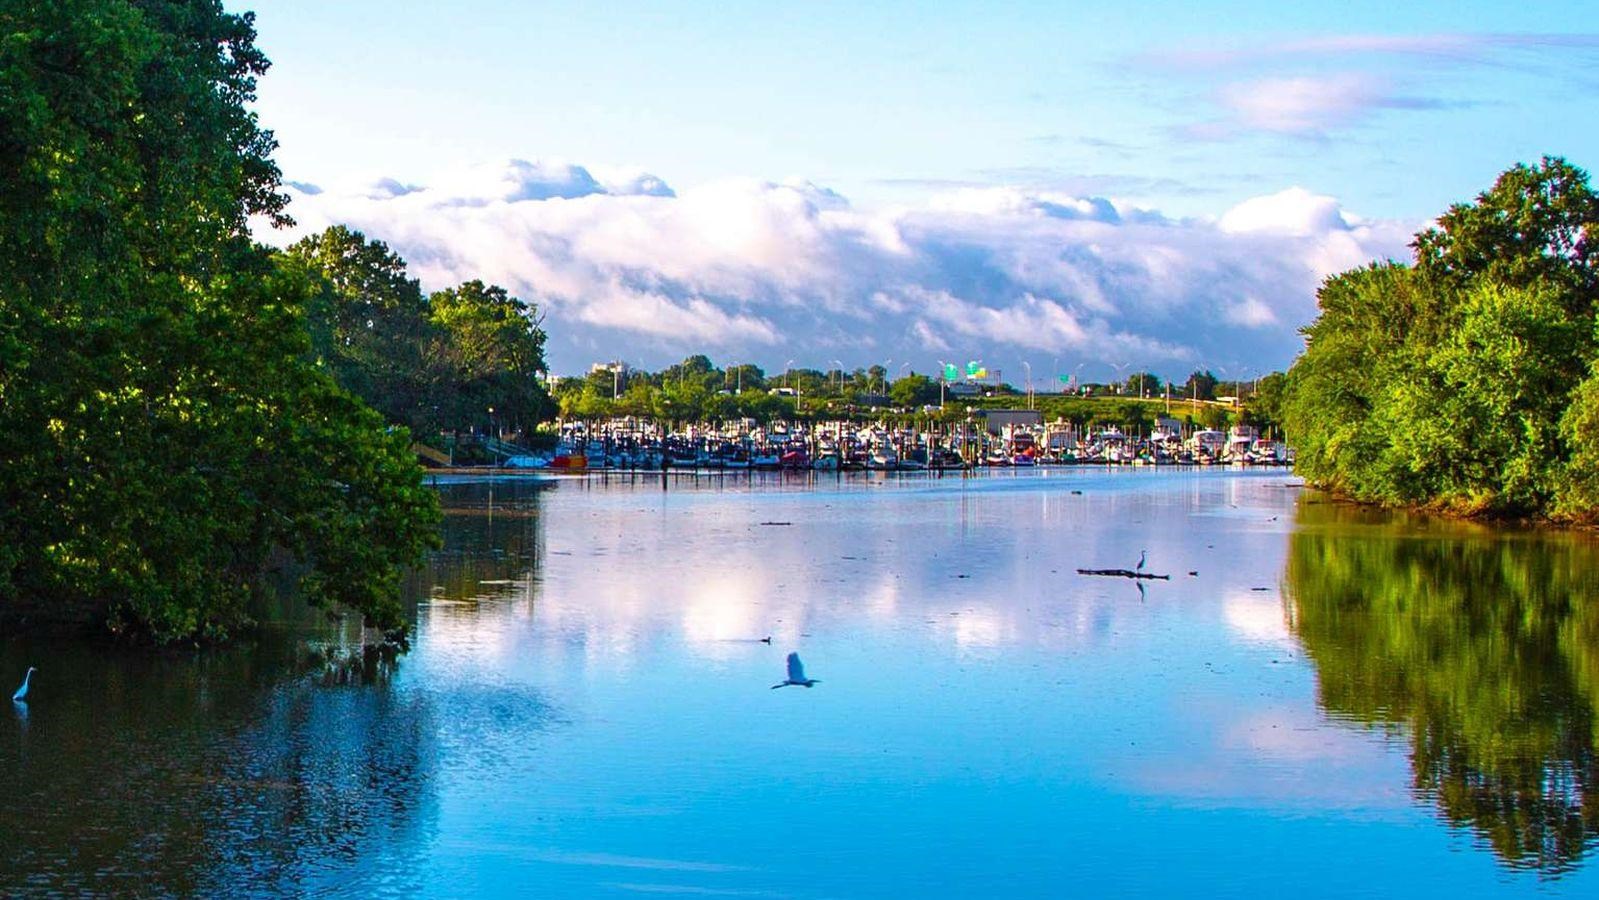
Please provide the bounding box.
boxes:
[239,0,1599,377]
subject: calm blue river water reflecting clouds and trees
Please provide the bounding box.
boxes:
[0,472,1599,898]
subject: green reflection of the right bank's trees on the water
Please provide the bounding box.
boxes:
[1284,497,1599,874]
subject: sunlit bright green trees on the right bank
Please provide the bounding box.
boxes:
[1279,158,1599,521]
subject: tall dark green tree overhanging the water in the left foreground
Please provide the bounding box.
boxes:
[0,0,438,641]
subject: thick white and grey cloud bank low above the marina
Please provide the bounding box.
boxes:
[262,160,1415,380]
